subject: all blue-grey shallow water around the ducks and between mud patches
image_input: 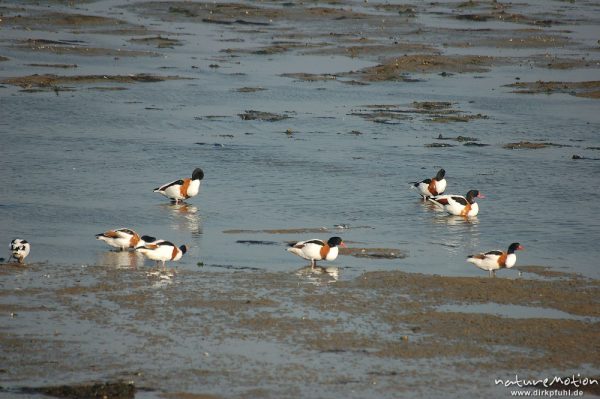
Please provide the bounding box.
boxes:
[0,1,600,397]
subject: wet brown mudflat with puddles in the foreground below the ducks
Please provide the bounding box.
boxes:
[0,261,600,397]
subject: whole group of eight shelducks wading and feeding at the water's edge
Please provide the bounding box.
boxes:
[9,168,523,275]
